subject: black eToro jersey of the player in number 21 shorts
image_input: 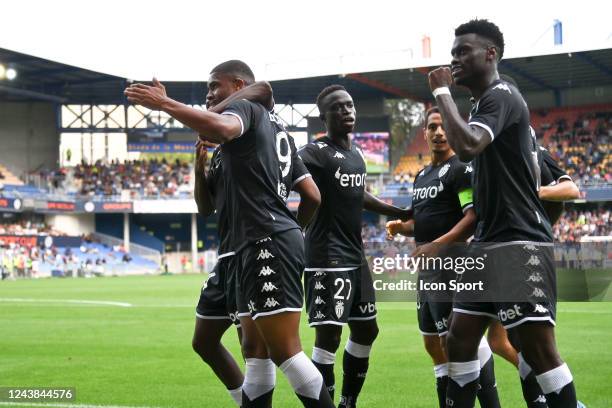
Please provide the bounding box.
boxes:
[298,136,366,269]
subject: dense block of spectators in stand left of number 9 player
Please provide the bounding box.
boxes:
[66,159,192,197]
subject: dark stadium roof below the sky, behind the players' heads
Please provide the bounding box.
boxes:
[0,49,612,104]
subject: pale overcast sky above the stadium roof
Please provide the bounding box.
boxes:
[0,0,612,81]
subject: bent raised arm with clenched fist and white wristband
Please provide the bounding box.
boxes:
[429,67,492,163]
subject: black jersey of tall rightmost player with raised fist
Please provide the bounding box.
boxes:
[469,80,552,242]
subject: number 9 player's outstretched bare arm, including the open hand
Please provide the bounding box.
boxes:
[124,78,242,143]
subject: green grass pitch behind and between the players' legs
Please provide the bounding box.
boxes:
[0,275,612,408]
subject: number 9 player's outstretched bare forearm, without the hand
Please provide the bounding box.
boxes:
[160,98,241,144]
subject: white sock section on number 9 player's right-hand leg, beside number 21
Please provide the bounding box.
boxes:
[279,351,323,400]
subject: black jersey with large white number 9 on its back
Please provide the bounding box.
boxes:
[221,99,299,252]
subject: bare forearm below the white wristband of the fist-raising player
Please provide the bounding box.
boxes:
[436,95,491,163]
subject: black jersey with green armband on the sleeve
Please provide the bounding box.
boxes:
[412,155,473,244]
